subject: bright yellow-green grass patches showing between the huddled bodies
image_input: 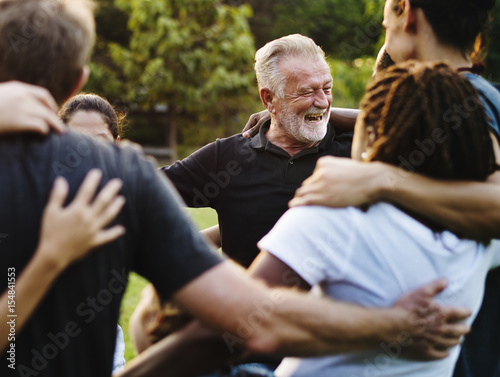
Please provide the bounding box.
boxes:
[119,208,217,361]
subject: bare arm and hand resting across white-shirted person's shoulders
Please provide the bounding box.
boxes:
[290,132,500,238]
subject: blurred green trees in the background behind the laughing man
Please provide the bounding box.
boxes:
[88,0,500,162]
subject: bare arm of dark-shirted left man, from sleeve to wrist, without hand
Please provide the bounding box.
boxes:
[174,261,411,356]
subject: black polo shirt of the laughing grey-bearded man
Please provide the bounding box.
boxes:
[161,122,352,267]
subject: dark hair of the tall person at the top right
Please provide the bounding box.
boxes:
[389,0,496,56]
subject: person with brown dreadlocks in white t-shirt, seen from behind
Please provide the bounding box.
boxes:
[250,62,500,377]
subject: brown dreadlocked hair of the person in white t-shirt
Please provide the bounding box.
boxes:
[361,61,496,181]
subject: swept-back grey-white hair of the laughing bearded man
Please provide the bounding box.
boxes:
[255,34,325,96]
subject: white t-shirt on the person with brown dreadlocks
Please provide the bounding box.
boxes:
[259,203,500,377]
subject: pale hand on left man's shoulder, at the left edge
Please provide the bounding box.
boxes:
[0,81,66,134]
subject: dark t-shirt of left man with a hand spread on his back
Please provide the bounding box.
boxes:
[0,132,221,377]
